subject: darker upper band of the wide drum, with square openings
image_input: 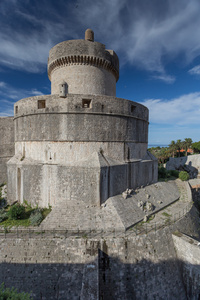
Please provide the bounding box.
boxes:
[14,95,148,143]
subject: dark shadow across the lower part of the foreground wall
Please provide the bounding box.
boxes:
[0,253,200,300]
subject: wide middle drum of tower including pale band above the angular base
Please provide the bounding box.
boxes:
[14,95,148,164]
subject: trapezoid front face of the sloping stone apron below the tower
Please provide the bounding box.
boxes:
[40,199,124,230]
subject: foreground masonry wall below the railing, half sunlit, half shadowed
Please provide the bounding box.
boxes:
[0,208,199,300]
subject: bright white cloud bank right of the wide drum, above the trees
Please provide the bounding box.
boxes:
[142,92,200,126]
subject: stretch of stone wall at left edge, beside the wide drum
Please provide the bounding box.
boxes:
[0,117,15,184]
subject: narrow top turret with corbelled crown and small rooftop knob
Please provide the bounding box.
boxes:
[48,29,119,96]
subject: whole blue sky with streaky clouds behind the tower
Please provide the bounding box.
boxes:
[0,0,200,144]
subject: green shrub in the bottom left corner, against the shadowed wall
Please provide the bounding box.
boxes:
[0,283,33,300]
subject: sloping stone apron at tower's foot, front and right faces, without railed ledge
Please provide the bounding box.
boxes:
[40,179,191,232]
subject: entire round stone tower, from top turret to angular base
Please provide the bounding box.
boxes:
[7,29,157,206]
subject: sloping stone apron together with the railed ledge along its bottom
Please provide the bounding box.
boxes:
[0,179,194,238]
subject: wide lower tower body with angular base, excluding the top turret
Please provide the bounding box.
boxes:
[8,94,157,206]
